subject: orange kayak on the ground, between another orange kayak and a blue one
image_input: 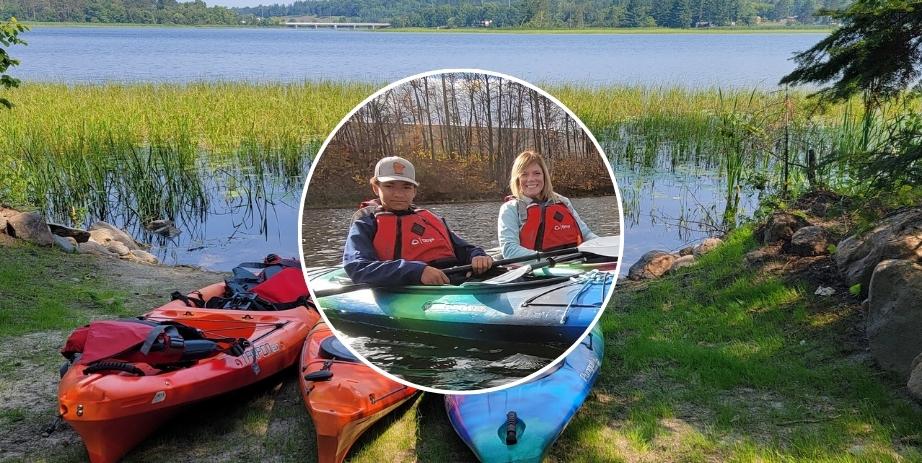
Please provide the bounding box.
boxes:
[298,322,416,463]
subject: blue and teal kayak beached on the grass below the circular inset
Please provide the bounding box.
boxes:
[445,326,604,463]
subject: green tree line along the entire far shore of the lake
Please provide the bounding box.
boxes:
[0,0,849,28]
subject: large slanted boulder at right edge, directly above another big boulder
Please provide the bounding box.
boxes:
[836,207,922,295]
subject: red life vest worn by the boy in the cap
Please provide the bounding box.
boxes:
[373,209,457,263]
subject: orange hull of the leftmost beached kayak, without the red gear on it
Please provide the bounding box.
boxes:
[58,283,320,463]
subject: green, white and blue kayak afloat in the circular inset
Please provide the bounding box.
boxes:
[307,264,614,347]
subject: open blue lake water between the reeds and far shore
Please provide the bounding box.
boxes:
[18,26,825,88]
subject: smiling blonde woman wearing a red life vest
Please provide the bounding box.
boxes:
[498,151,598,259]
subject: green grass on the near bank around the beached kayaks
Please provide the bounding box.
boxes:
[0,208,922,462]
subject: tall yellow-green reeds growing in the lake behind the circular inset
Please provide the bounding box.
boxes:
[0,82,872,219]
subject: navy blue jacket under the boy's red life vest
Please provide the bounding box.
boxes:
[343,211,487,286]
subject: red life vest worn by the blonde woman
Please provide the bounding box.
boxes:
[519,203,583,251]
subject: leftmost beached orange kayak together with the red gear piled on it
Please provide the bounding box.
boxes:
[58,256,320,463]
